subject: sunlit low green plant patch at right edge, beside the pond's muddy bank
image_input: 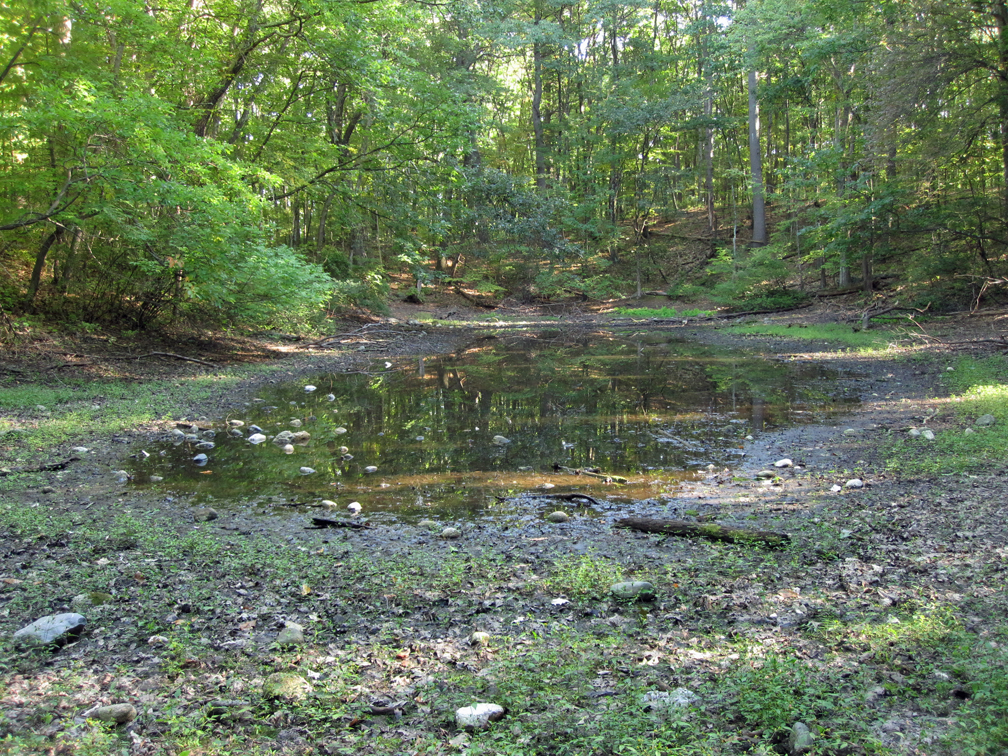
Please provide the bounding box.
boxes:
[884,355,1008,475]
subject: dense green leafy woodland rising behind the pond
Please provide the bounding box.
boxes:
[0,0,1008,328]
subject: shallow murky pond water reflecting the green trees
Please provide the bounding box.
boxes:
[132,333,857,520]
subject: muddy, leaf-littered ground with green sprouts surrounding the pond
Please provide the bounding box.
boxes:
[0,300,1008,756]
